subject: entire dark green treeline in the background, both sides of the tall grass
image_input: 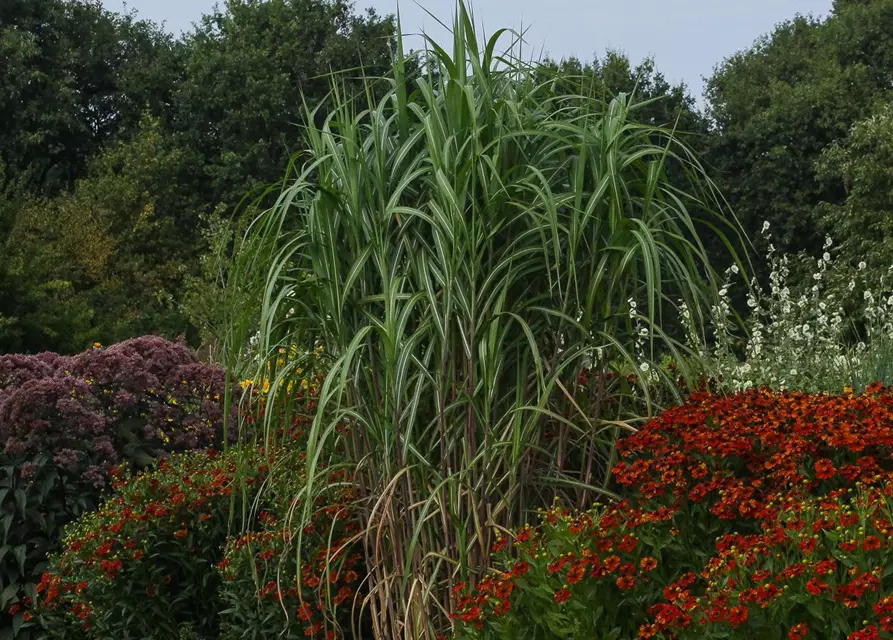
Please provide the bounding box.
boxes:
[0,0,893,353]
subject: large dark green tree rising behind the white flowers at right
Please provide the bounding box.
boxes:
[707,0,893,260]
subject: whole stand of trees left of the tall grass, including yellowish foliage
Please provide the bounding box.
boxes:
[0,0,394,353]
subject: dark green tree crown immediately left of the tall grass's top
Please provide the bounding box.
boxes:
[176,0,395,206]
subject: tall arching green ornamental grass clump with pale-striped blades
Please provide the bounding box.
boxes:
[233,3,732,638]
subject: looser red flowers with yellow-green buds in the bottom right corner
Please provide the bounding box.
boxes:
[640,478,893,640]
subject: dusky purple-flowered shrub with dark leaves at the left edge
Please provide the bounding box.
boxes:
[0,336,238,630]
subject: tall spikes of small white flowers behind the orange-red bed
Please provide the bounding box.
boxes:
[682,224,893,392]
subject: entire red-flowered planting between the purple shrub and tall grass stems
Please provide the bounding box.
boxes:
[37,376,362,640]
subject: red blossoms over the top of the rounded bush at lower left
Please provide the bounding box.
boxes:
[37,451,249,629]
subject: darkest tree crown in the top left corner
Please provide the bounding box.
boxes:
[0,0,179,194]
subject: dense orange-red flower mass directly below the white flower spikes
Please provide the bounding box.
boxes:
[614,385,893,521]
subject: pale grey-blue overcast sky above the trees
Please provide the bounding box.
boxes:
[106,0,832,97]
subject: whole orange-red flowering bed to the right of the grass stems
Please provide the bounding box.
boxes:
[454,385,893,640]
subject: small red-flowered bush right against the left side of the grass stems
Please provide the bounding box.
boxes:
[219,470,368,640]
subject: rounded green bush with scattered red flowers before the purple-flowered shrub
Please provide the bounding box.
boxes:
[37,449,265,639]
